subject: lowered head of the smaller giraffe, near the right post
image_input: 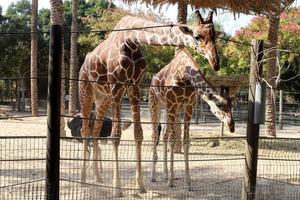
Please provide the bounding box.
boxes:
[202,91,236,133]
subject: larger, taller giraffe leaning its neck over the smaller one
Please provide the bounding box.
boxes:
[79,10,219,196]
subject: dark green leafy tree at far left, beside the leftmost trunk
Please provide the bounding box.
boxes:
[0,0,31,111]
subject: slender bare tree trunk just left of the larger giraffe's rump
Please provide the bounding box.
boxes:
[69,0,78,116]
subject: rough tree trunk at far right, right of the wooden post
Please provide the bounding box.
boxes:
[265,16,280,137]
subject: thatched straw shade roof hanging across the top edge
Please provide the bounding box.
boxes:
[119,0,295,15]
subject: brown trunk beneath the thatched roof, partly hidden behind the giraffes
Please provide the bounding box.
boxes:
[174,0,188,153]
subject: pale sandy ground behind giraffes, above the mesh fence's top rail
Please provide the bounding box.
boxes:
[0,102,300,140]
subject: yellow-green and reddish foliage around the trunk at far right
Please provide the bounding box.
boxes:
[223,8,300,97]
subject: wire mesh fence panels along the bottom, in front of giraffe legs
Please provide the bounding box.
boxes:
[0,137,300,200]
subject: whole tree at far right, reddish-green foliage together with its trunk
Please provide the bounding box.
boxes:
[225,8,300,136]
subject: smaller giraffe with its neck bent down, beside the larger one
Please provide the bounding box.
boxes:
[149,49,234,189]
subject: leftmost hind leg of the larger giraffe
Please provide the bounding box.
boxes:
[79,74,92,183]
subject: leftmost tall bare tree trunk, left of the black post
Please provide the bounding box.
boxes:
[30,0,39,117]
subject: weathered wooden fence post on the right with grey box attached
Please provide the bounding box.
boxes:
[242,40,263,200]
